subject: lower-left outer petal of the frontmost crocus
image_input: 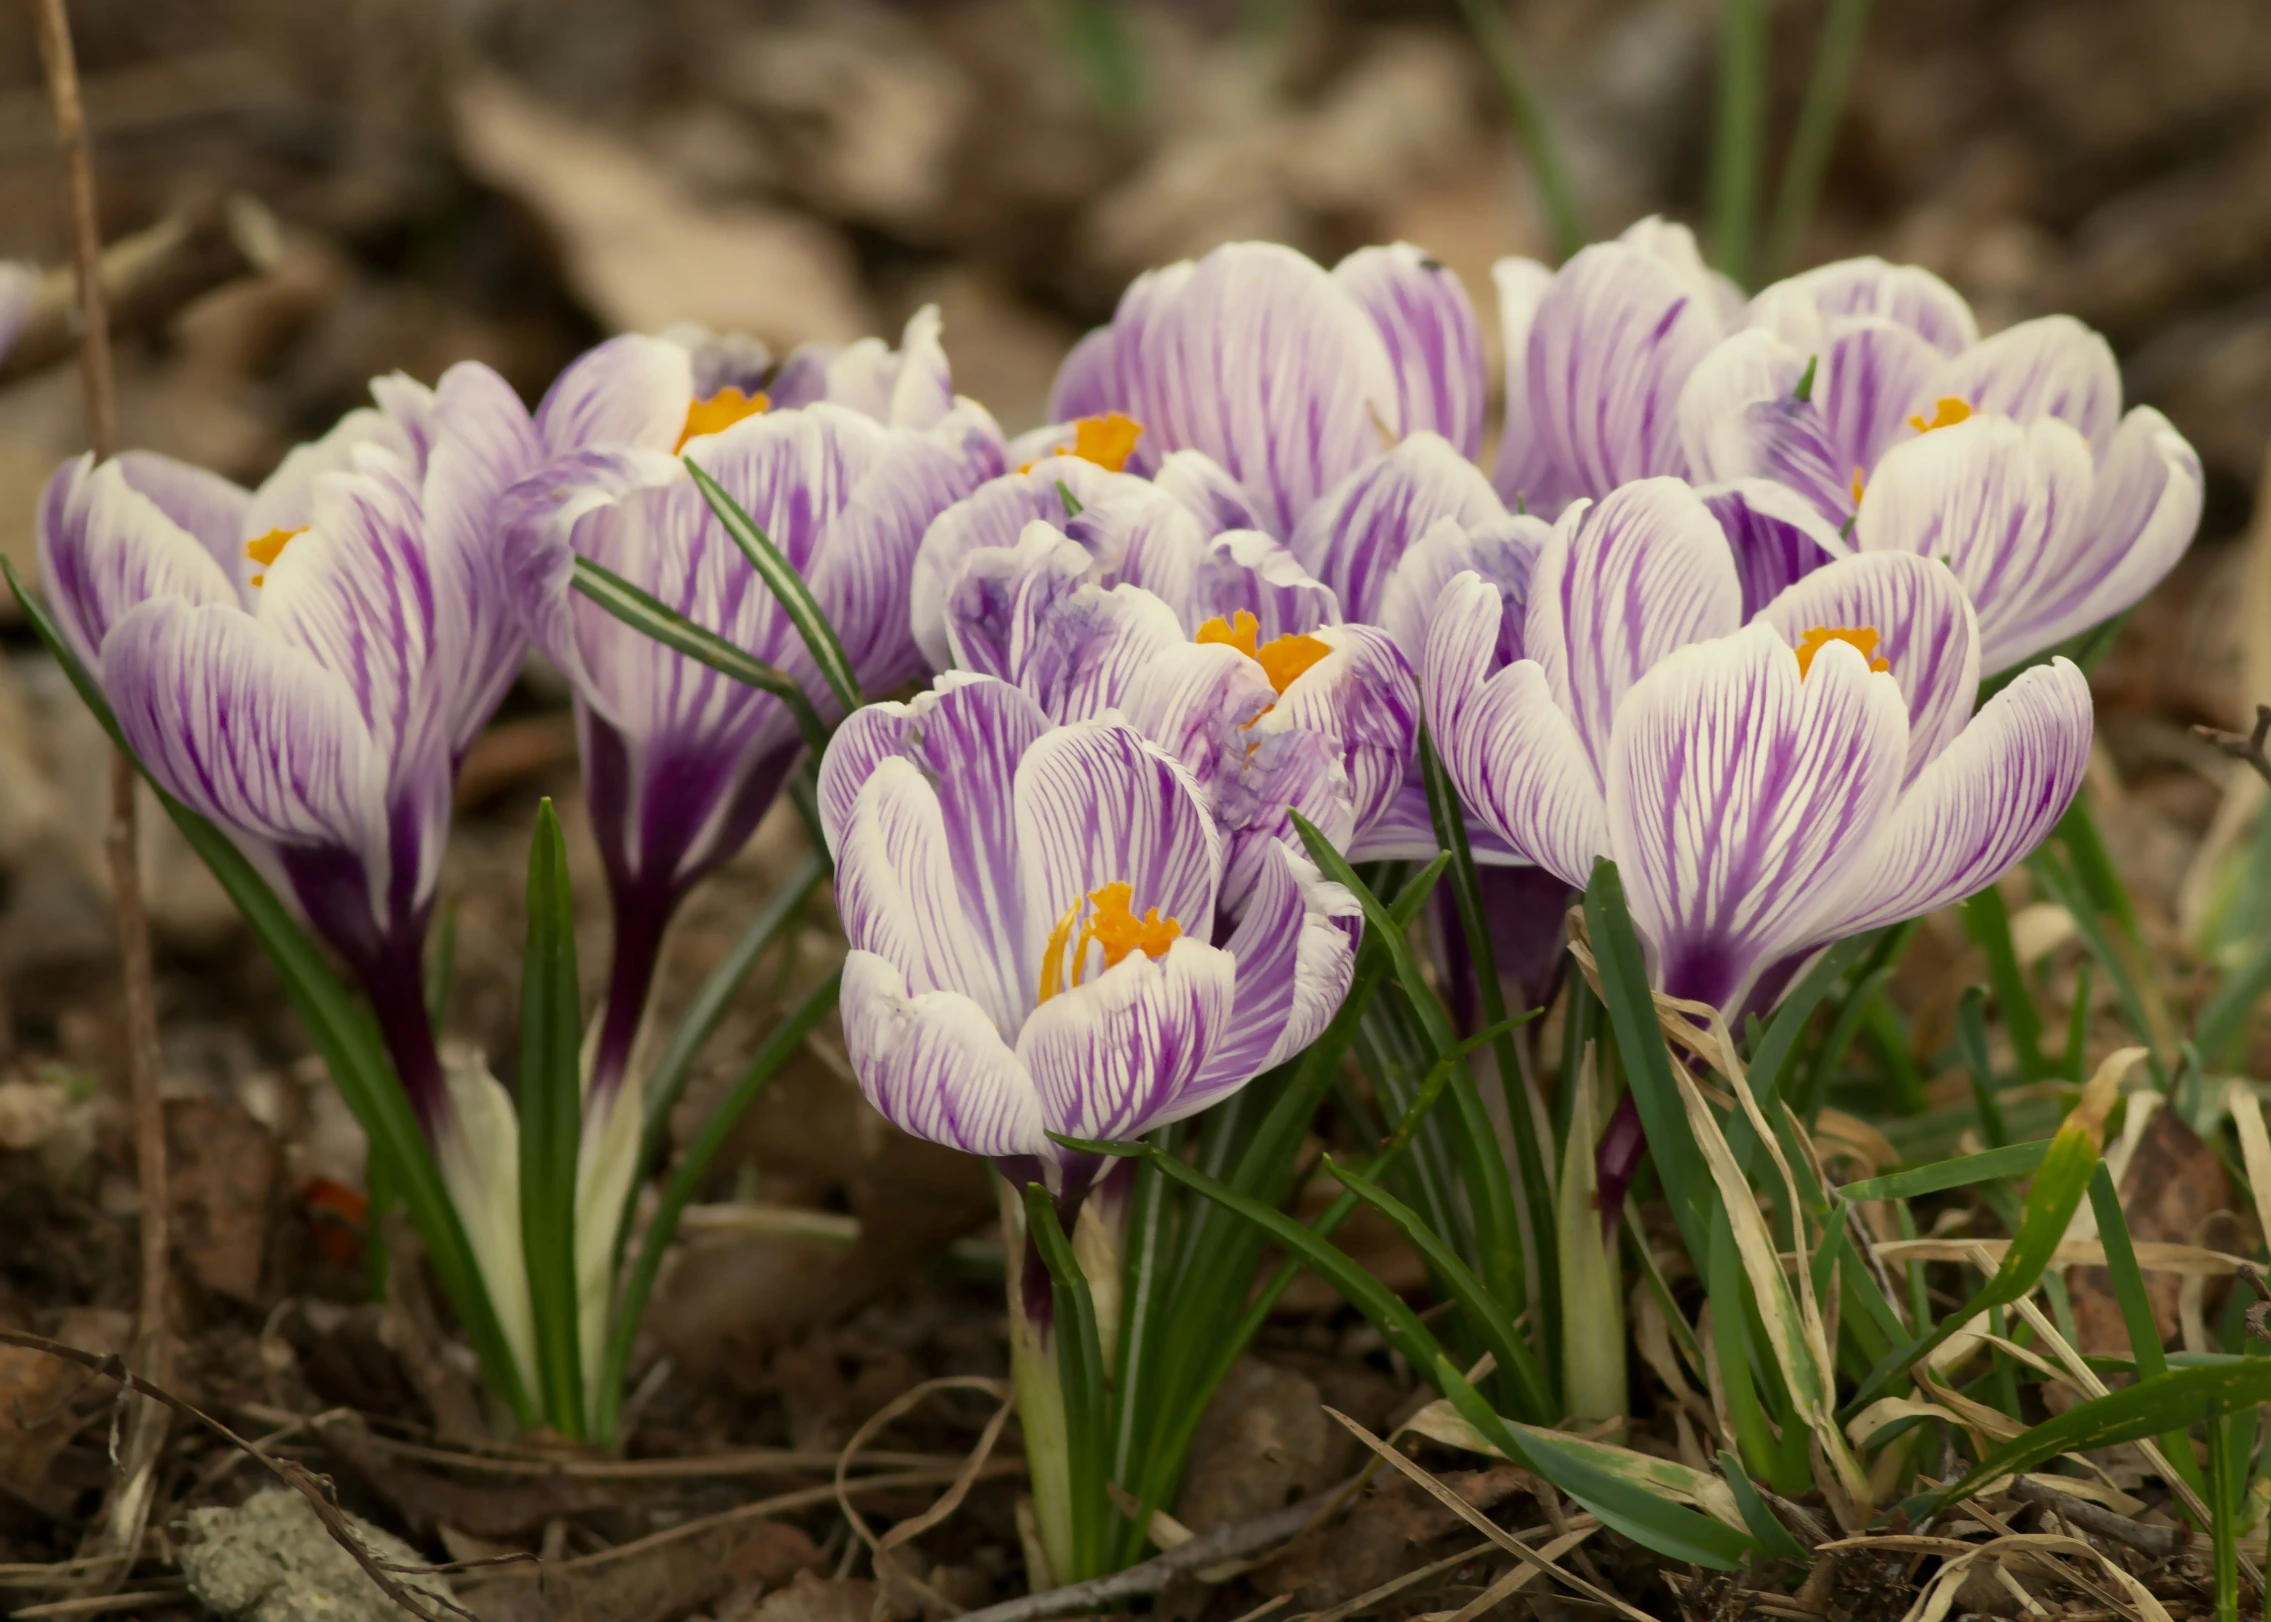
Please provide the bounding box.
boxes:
[843,950,1056,1163]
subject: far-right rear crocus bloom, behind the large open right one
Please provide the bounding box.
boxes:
[1678,259,2201,672]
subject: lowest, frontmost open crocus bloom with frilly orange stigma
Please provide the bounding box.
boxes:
[820,675,1358,1190]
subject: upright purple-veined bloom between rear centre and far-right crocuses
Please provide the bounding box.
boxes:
[1492,218,1742,516]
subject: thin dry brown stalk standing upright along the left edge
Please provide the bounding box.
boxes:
[32,0,170,1592]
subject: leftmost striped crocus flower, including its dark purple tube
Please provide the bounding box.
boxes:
[39,361,538,1136]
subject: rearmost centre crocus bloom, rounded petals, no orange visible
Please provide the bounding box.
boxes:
[1049,243,1483,541]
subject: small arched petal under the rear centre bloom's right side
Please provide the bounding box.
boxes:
[1292,434,1506,620]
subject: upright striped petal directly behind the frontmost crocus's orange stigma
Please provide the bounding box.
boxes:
[1015,720,1222,986]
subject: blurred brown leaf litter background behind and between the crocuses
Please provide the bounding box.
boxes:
[0,0,2271,1479]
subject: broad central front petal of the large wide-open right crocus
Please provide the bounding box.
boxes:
[1607,625,1908,1013]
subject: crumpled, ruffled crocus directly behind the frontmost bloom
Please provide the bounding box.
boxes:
[945,515,1433,915]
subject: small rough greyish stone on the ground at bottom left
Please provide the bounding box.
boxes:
[182,1488,450,1622]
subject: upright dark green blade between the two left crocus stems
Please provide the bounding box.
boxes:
[520,800,585,1440]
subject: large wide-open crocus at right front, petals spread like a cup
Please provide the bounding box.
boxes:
[1422,479,2089,1020]
